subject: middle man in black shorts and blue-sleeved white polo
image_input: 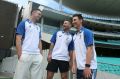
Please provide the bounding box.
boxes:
[46,20,73,79]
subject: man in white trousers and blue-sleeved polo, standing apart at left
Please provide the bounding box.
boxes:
[13,9,42,79]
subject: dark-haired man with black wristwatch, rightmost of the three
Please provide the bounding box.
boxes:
[72,14,97,79]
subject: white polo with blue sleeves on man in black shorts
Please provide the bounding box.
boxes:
[51,31,74,61]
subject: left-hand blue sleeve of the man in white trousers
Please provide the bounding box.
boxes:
[16,21,25,37]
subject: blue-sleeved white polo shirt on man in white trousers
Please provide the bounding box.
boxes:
[16,19,41,54]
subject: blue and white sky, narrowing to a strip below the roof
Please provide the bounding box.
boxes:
[6,0,118,20]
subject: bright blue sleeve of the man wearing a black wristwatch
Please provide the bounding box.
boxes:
[84,29,94,47]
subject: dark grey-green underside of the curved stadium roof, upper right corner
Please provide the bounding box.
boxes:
[56,0,120,18]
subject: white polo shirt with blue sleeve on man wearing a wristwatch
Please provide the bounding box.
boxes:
[73,27,97,70]
